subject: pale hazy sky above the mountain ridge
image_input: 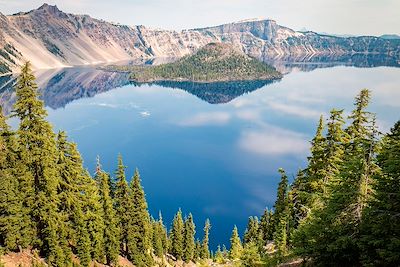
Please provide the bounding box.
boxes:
[0,0,400,35]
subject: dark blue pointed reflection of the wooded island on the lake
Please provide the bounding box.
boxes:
[133,81,273,104]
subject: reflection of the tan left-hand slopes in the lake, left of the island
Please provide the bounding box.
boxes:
[0,68,128,114]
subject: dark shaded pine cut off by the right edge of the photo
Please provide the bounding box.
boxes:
[361,121,400,266]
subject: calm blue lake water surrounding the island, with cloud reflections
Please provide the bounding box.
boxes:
[0,62,400,248]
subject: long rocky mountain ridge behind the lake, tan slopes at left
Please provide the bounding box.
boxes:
[0,4,400,74]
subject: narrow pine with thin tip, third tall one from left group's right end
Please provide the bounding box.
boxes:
[95,161,119,265]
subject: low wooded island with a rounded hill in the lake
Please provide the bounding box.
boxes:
[104,43,282,83]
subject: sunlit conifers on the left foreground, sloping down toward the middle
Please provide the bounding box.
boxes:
[0,63,211,267]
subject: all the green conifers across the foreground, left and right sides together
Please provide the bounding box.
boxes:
[0,63,400,267]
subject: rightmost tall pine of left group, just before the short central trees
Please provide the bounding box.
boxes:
[128,169,152,267]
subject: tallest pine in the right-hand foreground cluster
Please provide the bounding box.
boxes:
[315,90,378,265]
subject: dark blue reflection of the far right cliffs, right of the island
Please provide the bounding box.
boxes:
[262,54,400,74]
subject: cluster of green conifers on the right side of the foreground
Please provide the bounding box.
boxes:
[231,89,400,266]
